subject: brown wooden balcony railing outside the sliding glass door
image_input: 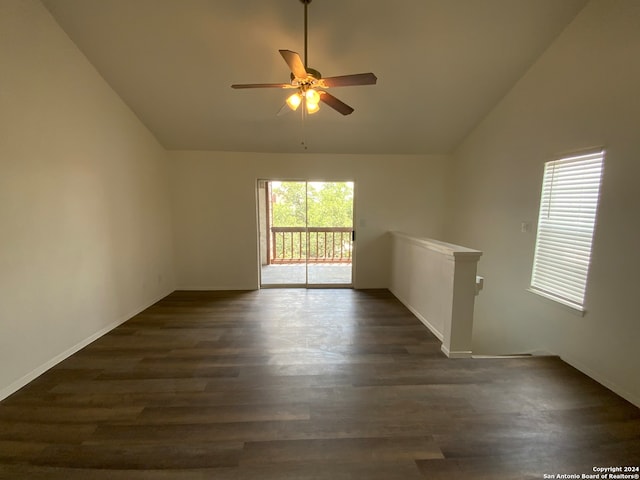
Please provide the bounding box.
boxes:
[271,227,353,263]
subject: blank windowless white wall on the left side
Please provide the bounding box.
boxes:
[0,0,174,398]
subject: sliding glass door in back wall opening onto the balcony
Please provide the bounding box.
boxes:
[258,180,353,287]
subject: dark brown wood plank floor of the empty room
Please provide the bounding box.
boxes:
[0,289,640,480]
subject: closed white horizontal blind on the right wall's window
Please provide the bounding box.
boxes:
[531,151,604,310]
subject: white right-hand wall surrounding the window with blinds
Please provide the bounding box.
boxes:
[447,0,640,404]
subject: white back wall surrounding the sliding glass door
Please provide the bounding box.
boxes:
[170,152,446,289]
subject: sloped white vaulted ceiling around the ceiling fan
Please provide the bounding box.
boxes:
[43,0,586,153]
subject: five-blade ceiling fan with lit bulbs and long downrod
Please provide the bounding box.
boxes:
[231,0,378,115]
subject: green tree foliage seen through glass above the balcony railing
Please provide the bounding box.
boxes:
[272,182,353,227]
